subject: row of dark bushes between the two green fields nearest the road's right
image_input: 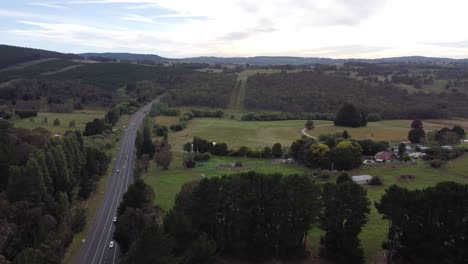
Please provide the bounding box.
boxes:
[184,137,284,158]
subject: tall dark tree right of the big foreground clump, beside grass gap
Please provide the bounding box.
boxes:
[320,181,370,263]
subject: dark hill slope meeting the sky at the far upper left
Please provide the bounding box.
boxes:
[0,45,80,69]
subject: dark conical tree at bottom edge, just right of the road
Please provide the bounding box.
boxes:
[123,224,176,264]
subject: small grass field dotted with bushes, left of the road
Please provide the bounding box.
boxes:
[13,110,105,134]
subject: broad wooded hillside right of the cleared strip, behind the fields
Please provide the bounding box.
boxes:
[245,71,468,119]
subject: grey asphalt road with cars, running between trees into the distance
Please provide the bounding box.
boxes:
[77,97,160,264]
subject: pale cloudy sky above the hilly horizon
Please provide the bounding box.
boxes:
[0,0,468,58]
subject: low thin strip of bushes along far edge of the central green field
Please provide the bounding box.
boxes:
[241,112,335,121]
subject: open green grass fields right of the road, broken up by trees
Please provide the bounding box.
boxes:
[145,117,468,263]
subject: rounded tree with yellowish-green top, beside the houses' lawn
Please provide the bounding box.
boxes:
[329,140,362,170]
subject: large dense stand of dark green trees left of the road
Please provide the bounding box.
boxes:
[0,121,110,263]
